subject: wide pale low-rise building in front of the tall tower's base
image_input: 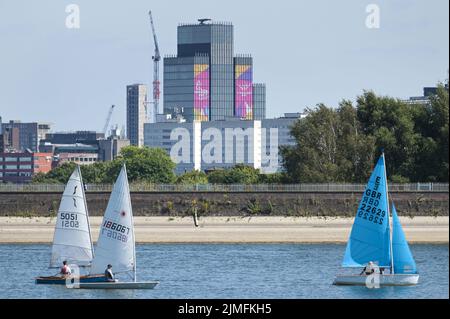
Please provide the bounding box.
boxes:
[144,113,303,174]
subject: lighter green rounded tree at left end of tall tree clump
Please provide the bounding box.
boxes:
[281,101,374,183]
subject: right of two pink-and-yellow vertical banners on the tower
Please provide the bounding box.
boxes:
[235,65,253,120]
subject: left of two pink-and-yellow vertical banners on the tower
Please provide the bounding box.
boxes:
[194,64,209,121]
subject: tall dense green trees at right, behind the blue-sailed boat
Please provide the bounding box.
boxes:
[281,80,449,183]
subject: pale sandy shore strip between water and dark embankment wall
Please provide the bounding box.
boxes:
[0,217,449,243]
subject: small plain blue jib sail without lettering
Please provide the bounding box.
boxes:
[392,204,417,274]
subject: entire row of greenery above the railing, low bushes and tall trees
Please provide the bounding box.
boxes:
[33,80,449,184]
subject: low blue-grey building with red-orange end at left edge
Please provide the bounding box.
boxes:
[0,152,52,183]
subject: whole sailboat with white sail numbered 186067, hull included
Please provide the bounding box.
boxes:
[75,164,159,289]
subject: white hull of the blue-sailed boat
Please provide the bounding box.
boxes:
[333,274,419,286]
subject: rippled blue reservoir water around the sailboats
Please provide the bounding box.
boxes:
[0,244,449,299]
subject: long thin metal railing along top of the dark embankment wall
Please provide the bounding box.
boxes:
[0,183,449,193]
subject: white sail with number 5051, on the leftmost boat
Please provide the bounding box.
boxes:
[50,167,93,267]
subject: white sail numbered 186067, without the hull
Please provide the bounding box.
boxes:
[90,165,135,277]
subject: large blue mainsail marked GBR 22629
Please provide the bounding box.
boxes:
[342,154,391,267]
